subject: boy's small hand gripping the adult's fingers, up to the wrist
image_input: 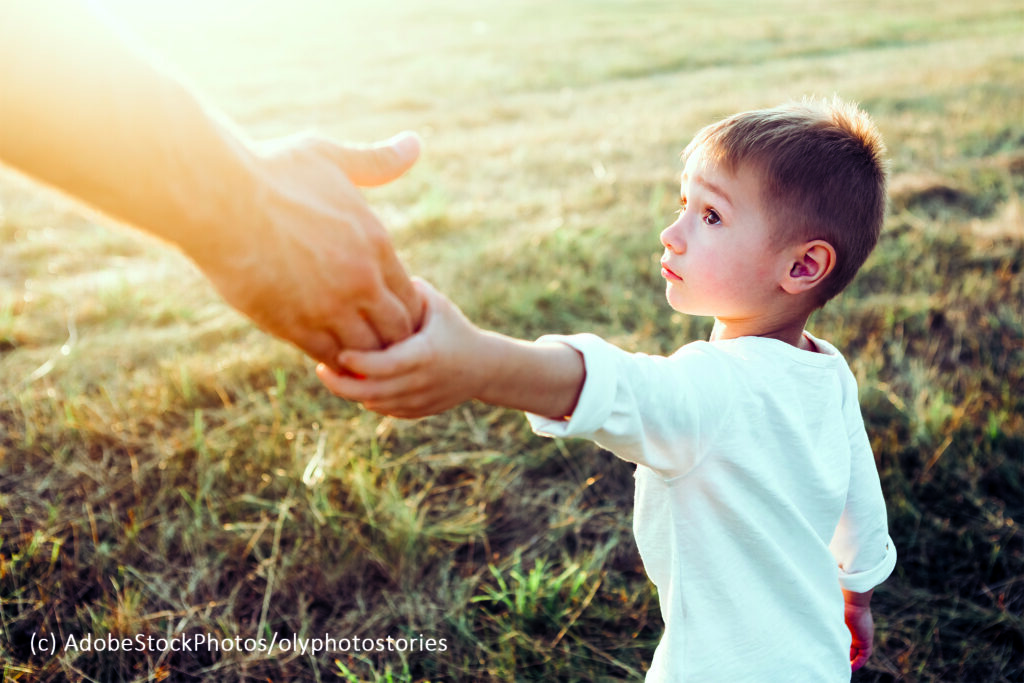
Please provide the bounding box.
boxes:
[316,280,487,418]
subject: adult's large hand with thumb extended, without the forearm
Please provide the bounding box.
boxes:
[189,127,423,368]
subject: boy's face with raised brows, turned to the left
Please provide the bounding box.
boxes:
[662,150,790,322]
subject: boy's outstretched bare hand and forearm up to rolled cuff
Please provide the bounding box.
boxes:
[316,281,586,418]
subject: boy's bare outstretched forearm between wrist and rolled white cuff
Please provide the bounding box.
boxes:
[476,333,587,418]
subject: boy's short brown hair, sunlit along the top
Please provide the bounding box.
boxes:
[682,97,888,305]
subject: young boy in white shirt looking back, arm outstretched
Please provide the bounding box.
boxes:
[317,100,896,683]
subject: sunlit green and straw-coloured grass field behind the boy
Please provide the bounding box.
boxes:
[0,0,1024,683]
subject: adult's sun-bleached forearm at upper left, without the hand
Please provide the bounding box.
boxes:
[0,0,257,258]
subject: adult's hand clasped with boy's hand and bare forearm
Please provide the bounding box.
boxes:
[219,129,586,419]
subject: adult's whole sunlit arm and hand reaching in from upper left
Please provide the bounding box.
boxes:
[0,0,421,366]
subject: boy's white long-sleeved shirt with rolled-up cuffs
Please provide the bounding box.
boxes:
[527,335,896,683]
